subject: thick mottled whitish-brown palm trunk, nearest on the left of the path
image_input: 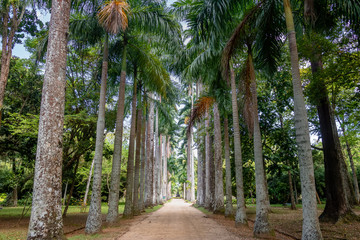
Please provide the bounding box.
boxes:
[27,0,70,239]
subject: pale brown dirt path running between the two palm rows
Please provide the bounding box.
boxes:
[117,199,242,240]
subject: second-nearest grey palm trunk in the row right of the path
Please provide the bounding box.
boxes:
[248,51,275,237]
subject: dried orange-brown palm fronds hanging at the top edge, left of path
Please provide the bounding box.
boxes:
[97,0,129,34]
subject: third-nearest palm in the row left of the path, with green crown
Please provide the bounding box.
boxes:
[107,0,177,222]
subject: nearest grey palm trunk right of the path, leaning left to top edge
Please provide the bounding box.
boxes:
[284,0,322,240]
